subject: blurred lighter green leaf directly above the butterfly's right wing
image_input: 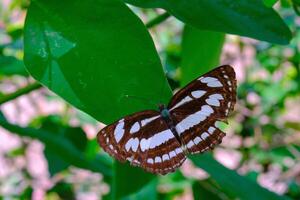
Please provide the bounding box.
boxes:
[181,26,225,86]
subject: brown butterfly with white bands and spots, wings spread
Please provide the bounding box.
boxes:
[97,65,236,174]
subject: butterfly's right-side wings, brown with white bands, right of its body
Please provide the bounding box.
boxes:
[168,65,236,153]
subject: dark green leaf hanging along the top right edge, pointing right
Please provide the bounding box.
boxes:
[125,0,292,44]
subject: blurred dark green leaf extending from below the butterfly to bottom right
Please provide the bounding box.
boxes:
[190,154,289,200]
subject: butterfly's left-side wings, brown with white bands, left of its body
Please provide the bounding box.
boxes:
[97,110,186,174]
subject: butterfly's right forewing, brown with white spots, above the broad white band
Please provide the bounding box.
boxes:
[168,65,236,118]
